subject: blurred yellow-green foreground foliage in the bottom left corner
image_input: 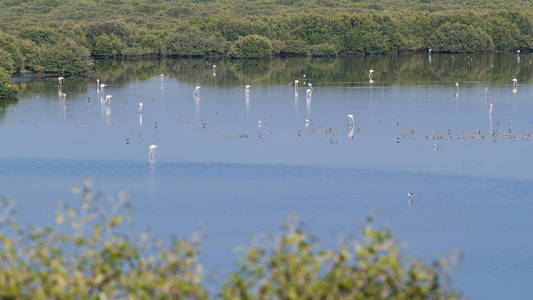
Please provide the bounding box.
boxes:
[0,180,207,299]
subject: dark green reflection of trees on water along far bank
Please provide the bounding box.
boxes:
[13,54,533,97]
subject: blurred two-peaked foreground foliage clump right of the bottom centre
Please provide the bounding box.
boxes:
[223,214,459,299]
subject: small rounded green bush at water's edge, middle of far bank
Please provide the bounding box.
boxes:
[229,34,274,58]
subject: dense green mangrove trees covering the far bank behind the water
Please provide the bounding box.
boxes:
[0,0,533,96]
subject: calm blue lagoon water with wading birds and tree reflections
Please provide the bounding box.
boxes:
[0,55,533,299]
